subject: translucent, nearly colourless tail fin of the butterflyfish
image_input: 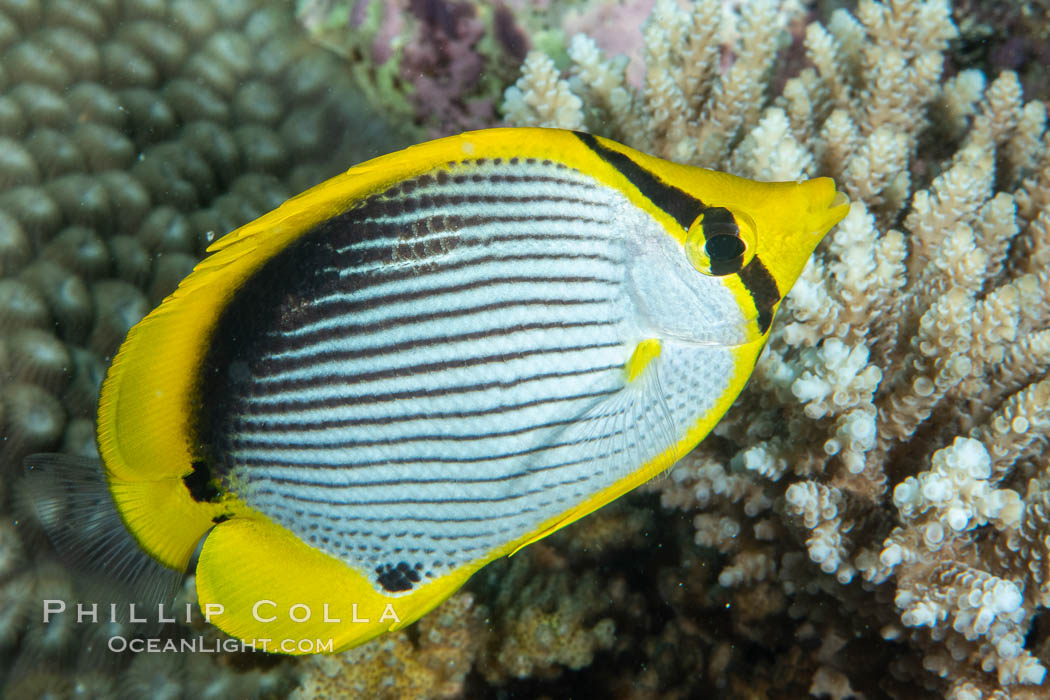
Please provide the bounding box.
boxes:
[23,454,185,613]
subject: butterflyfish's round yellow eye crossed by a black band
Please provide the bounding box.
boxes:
[686,207,757,277]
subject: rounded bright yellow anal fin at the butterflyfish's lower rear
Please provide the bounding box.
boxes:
[196,517,478,655]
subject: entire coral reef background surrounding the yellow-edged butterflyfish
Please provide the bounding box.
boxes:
[0,0,1050,700]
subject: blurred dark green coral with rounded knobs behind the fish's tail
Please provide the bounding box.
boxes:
[0,0,403,698]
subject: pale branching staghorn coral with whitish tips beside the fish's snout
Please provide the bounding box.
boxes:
[504,0,1050,698]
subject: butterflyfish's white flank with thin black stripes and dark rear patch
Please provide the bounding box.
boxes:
[195,158,729,592]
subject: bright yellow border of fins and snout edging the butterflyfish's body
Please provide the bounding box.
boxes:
[99,129,848,653]
